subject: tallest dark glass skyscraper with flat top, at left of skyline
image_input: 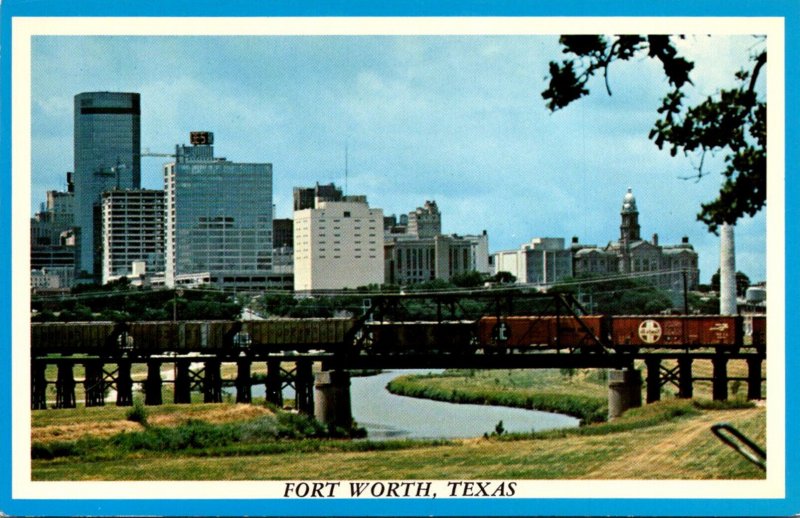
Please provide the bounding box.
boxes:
[74,92,141,277]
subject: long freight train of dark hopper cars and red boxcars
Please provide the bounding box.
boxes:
[31,315,766,357]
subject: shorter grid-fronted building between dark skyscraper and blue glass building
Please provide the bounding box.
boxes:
[102,189,164,284]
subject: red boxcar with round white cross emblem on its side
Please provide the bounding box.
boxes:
[611,315,742,348]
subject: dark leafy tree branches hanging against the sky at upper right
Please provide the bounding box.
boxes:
[542,35,767,233]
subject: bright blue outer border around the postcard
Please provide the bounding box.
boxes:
[0,0,800,516]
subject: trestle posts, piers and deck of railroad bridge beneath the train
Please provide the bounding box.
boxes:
[31,351,764,428]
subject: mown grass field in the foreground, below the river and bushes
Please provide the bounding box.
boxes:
[32,401,765,480]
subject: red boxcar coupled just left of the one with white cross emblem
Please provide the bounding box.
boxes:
[478,316,605,350]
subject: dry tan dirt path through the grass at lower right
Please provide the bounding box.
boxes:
[585,408,759,479]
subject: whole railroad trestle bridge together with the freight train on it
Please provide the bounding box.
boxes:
[30,291,766,426]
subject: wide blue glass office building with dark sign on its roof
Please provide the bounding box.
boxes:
[164,131,282,291]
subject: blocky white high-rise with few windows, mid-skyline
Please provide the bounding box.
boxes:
[294,196,384,292]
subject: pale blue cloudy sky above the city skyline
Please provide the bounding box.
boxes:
[31,35,766,282]
